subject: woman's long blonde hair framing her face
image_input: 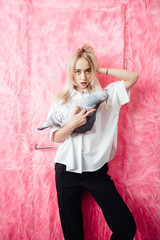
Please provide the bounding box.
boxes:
[53,44,102,104]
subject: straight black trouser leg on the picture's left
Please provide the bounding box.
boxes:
[55,164,84,240]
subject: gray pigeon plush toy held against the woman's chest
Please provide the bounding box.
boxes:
[37,89,109,133]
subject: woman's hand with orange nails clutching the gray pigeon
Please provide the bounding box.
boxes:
[69,106,96,129]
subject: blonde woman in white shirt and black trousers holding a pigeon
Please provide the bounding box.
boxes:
[48,44,138,240]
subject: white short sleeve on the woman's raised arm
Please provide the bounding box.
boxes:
[105,80,130,106]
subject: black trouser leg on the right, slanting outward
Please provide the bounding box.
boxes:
[86,165,136,240]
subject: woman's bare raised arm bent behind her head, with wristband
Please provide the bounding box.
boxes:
[97,67,138,91]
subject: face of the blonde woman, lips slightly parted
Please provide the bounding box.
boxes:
[73,57,91,92]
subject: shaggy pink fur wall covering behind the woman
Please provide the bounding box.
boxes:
[0,0,160,240]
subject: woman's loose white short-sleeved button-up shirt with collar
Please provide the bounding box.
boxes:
[48,80,130,173]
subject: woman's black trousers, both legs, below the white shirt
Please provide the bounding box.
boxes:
[55,163,136,240]
